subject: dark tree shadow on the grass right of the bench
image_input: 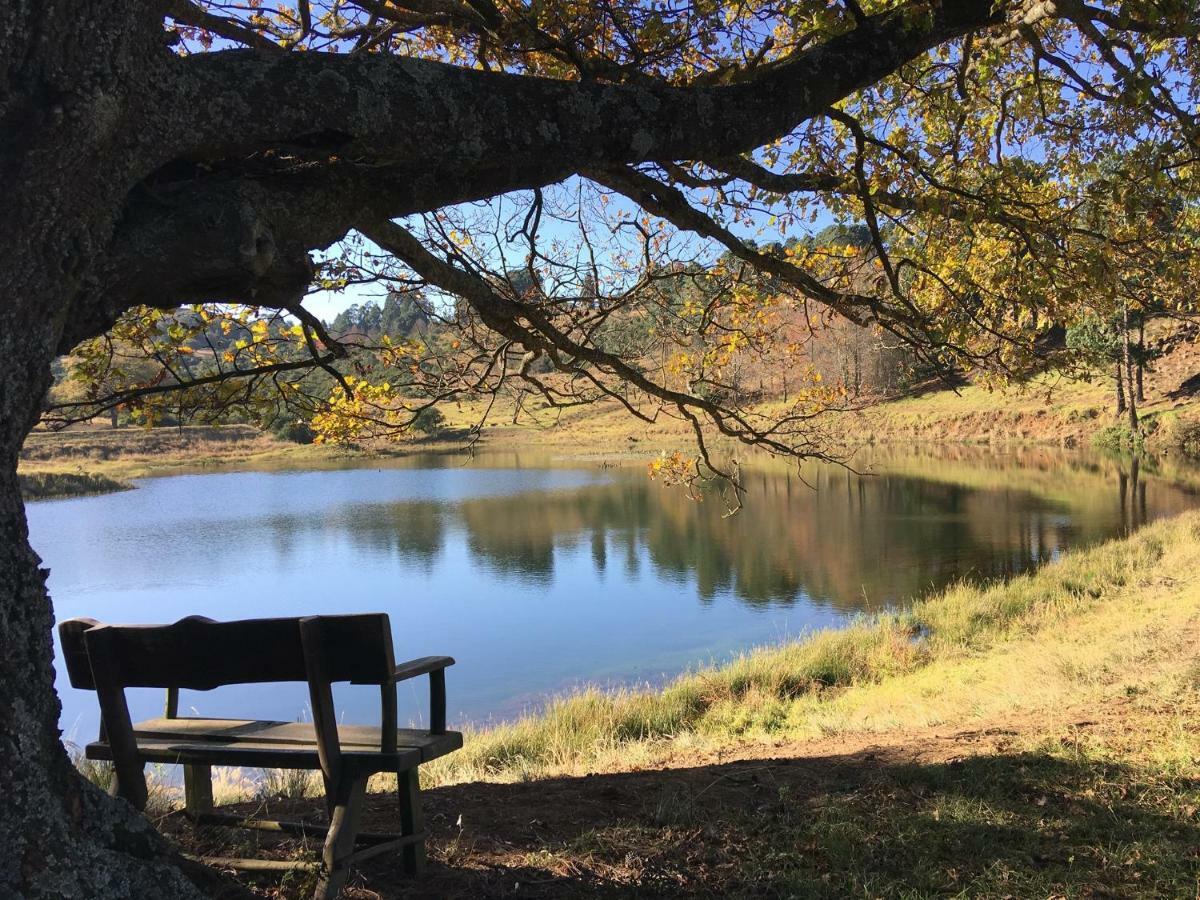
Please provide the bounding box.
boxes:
[177,742,1200,898]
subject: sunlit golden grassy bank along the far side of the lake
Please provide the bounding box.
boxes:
[20,367,1200,494]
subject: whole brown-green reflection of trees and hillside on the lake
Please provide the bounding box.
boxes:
[253,461,1194,610]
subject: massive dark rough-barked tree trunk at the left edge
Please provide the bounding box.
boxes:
[0,0,244,898]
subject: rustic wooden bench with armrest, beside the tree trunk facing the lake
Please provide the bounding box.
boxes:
[59,613,462,898]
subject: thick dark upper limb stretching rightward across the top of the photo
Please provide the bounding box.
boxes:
[159,0,1003,170]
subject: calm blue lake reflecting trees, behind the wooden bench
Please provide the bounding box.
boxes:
[28,450,1196,742]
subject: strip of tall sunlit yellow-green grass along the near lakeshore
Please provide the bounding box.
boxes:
[415,514,1200,782]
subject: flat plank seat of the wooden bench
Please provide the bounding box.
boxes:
[133,718,462,762]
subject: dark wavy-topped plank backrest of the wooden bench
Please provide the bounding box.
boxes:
[59,613,395,690]
